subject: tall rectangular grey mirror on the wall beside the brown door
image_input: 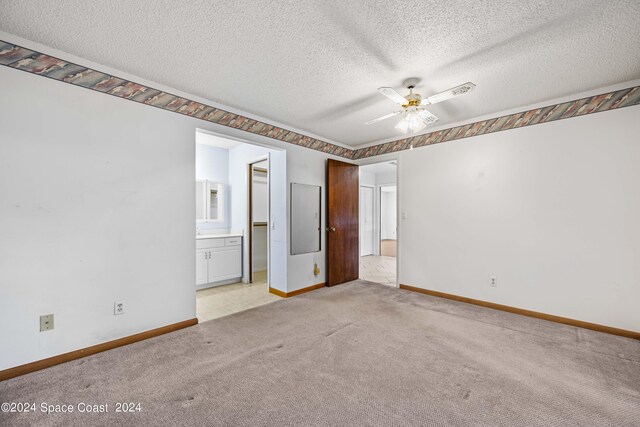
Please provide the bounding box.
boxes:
[291,183,322,255]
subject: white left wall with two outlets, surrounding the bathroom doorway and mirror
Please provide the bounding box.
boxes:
[0,35,342,370]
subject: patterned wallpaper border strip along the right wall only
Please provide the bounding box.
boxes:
[351,86,640,160]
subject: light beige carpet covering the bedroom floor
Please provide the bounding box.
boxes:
[0,281,640,427]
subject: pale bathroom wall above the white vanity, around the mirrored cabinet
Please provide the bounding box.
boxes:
[196,144,231,229]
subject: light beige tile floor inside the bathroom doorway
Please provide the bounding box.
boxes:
[196,271,281,322]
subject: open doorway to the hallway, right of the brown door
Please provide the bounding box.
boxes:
[360,160,398,286]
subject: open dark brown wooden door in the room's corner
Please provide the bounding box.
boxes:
[326,159,360,286]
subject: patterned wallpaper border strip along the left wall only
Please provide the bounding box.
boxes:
[0,40,353,159]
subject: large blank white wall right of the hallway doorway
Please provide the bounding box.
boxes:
[399,106,640,331]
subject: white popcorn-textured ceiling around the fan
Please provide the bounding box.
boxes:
[0,0,640,146]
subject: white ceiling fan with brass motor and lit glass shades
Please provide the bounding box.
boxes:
[365,78,476,133]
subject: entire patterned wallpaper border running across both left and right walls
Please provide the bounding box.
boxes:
[0,40,640,160]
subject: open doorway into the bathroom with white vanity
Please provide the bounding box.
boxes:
[195,130,286,322]
